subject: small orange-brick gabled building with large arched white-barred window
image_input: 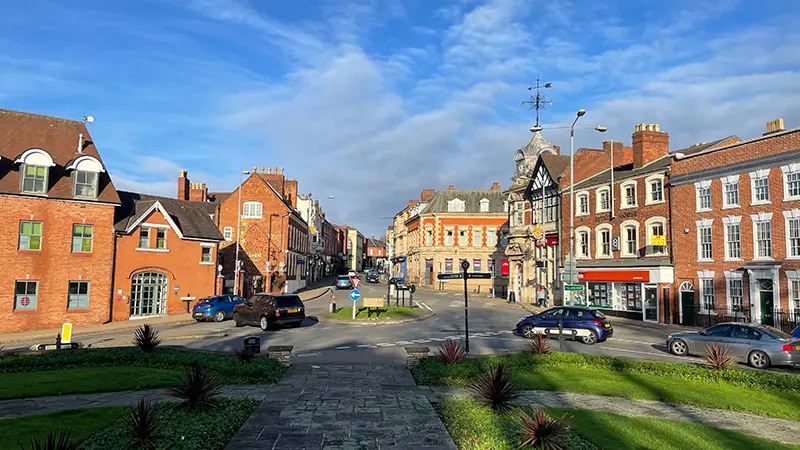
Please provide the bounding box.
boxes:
[113,191,223,320]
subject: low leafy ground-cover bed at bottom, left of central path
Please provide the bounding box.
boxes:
[78,398,259,450]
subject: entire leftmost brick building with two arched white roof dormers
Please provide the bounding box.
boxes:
[0,109,119,333]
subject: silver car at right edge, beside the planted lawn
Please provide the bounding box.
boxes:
[667,322,800,369]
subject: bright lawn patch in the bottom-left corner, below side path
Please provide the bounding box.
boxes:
[0,407,128,449]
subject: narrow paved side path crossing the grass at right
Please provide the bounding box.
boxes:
[419,386,800,445]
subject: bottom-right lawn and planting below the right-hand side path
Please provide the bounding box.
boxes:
[440,398,797,450]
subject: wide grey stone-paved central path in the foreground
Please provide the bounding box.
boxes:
[226,364,456,450]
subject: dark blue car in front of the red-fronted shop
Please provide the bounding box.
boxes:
[515,306,614,345]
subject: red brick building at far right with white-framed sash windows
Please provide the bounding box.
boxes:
[669,119,800,328]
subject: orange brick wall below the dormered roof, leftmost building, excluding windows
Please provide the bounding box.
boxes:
[0,196,114,338]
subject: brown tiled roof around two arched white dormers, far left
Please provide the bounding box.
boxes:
[0,108,119,203]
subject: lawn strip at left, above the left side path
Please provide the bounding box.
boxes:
[0,366,183,399]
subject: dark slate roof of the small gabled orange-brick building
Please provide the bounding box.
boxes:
[114,191,224,241]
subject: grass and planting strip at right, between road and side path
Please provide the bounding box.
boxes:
[412,352,800,420]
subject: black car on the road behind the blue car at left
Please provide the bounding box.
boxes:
[233,294,306,331]
